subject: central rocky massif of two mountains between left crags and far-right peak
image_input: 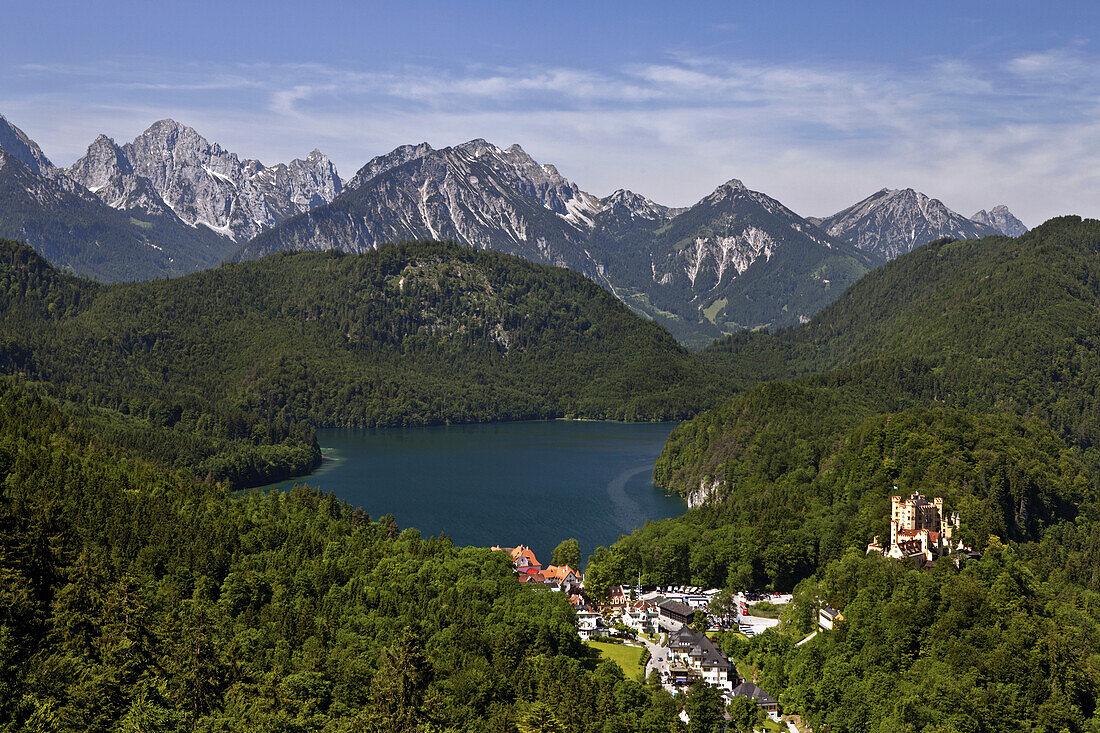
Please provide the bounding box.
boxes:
[237,140,878,346]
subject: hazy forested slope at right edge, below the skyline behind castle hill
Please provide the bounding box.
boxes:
[711,217,1100,447]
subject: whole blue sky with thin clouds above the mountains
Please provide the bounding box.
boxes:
[0,0,1100,226]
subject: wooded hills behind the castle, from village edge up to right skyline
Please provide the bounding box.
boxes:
[596,217,1100,588]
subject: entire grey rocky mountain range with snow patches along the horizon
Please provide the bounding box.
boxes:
[0,117,1026,346]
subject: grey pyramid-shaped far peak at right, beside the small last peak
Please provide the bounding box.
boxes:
[821,188,998,260]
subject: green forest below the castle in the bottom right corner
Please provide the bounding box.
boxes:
[721,545,1100,733]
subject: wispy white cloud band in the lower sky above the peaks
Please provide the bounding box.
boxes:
[0,44,1100,225]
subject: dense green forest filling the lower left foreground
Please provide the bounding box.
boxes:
[0,380,679,733]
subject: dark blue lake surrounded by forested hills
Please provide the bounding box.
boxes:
[261,420,686,564]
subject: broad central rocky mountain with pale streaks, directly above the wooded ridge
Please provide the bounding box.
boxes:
[238,140,597,276]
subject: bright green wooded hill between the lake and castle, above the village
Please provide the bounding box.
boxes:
[586,402,1097,591]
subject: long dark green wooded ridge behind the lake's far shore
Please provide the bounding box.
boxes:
[0,236,728,435]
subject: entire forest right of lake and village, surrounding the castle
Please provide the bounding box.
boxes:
[587,217,1100,733]
